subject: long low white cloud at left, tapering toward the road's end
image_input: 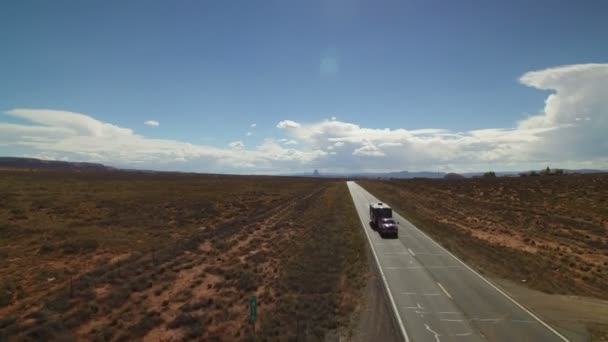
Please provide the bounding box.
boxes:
[0,108,326,173]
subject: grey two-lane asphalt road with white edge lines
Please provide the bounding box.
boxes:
[347,182,567,342]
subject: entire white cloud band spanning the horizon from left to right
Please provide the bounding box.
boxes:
[0,64,608,173]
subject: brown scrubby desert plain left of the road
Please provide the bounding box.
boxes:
[0,169,367,341]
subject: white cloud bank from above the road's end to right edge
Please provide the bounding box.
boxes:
[274,64,608,171]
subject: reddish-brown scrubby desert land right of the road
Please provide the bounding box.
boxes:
[360,174,608,340]
